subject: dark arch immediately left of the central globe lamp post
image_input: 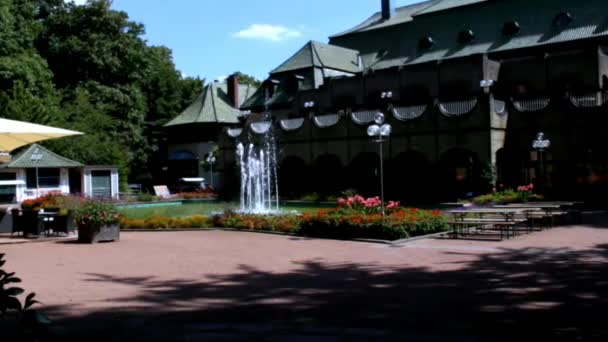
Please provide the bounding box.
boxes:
[348,152,380,196]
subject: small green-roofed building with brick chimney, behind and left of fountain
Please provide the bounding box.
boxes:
[165,74,257,188]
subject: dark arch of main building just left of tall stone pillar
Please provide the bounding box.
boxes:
[438,148,483,200]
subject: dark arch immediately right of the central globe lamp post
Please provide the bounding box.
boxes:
[385,150,434,205]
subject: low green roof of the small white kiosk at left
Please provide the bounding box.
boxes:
[1,144,83,169]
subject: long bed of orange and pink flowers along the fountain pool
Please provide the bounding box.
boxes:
[120,196,448,240]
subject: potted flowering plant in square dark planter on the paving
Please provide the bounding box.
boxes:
[75,200,120,243]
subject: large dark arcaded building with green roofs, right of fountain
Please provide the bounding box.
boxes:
[223,0,608,202]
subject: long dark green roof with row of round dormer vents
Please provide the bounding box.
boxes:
[331,0,608,69]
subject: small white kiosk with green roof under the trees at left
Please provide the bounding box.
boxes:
[0,144,119,204]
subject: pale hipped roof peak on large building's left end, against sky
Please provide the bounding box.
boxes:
[270,41,361,74]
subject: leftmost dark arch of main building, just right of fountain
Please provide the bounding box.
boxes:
[277,156,310,199]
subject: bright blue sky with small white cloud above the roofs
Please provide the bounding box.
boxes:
[97,0,415,81]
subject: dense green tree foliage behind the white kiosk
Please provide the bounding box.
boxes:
[0,0,202,183]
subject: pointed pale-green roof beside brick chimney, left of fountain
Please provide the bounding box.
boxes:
[165,82,256,127]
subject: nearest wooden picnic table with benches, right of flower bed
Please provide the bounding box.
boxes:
[447,208,536,239]
